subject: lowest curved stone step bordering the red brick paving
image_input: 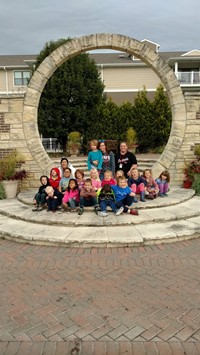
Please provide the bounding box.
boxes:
[0,206,200,247]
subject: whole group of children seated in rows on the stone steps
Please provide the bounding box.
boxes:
[33,162,170,217]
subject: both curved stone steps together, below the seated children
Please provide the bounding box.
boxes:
[0,186,200,247]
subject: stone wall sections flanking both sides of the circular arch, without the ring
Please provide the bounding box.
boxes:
[0,92,200,187]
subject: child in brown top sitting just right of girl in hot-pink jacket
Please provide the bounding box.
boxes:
[78,179,98,215]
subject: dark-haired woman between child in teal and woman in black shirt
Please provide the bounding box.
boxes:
[99,141,115,181]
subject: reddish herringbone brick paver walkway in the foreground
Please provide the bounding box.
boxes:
[0,239,200,355]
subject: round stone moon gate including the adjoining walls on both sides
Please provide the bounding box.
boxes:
[0,33,200,186]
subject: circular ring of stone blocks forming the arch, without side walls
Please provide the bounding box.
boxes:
[22,33,186,174]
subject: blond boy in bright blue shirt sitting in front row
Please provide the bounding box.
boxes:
[111,176,138,216]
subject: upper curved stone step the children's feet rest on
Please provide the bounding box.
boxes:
[0,189,200,227]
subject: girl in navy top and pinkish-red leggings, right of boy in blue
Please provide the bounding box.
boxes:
[128,168,146,202]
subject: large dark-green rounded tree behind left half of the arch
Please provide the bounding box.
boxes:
[36,39,104,149]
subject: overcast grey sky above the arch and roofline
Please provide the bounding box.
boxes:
[0,0,200,55]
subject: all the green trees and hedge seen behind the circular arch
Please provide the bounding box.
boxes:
[36,38,171,152]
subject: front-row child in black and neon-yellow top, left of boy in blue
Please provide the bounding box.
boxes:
[97,184,118,217]
